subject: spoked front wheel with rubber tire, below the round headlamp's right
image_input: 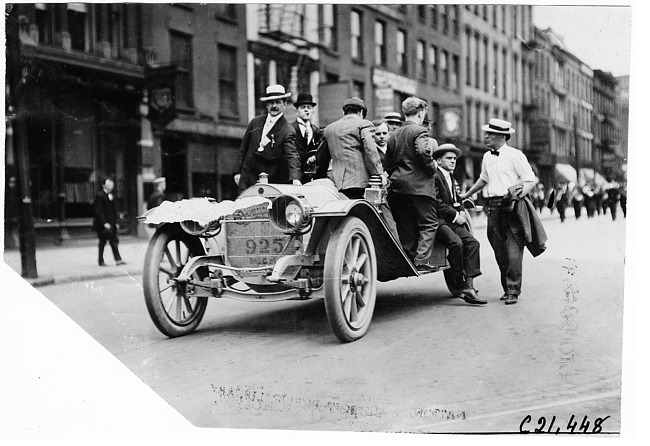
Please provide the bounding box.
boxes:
[324,217,377,342]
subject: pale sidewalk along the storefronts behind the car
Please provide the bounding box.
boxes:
[4,209,560,287]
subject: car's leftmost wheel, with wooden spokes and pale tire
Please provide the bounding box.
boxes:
[142,224,208,338]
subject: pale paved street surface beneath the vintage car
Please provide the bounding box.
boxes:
[10,211,625,432]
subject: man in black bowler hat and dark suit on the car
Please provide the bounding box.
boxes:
[291,93,321,183]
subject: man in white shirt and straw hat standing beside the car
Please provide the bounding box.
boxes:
[459,118,535,305]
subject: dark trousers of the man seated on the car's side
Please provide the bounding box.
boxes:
[436,223,481,282]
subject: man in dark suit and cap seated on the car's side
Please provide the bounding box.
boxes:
[433,144,487,305]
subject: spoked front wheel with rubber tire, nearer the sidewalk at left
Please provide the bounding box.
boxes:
[142,223,208,338]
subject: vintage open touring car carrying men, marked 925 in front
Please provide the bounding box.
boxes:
[140,178,473,342]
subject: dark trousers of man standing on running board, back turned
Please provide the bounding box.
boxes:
[388,192,438,265]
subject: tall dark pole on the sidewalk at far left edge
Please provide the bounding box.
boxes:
[5,5,38,278]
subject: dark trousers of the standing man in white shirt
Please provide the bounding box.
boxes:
[487,203,524,296]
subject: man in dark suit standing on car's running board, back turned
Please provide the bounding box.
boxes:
[385,97,438,273]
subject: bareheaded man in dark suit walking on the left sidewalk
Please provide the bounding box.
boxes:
[93,178,126,266]
